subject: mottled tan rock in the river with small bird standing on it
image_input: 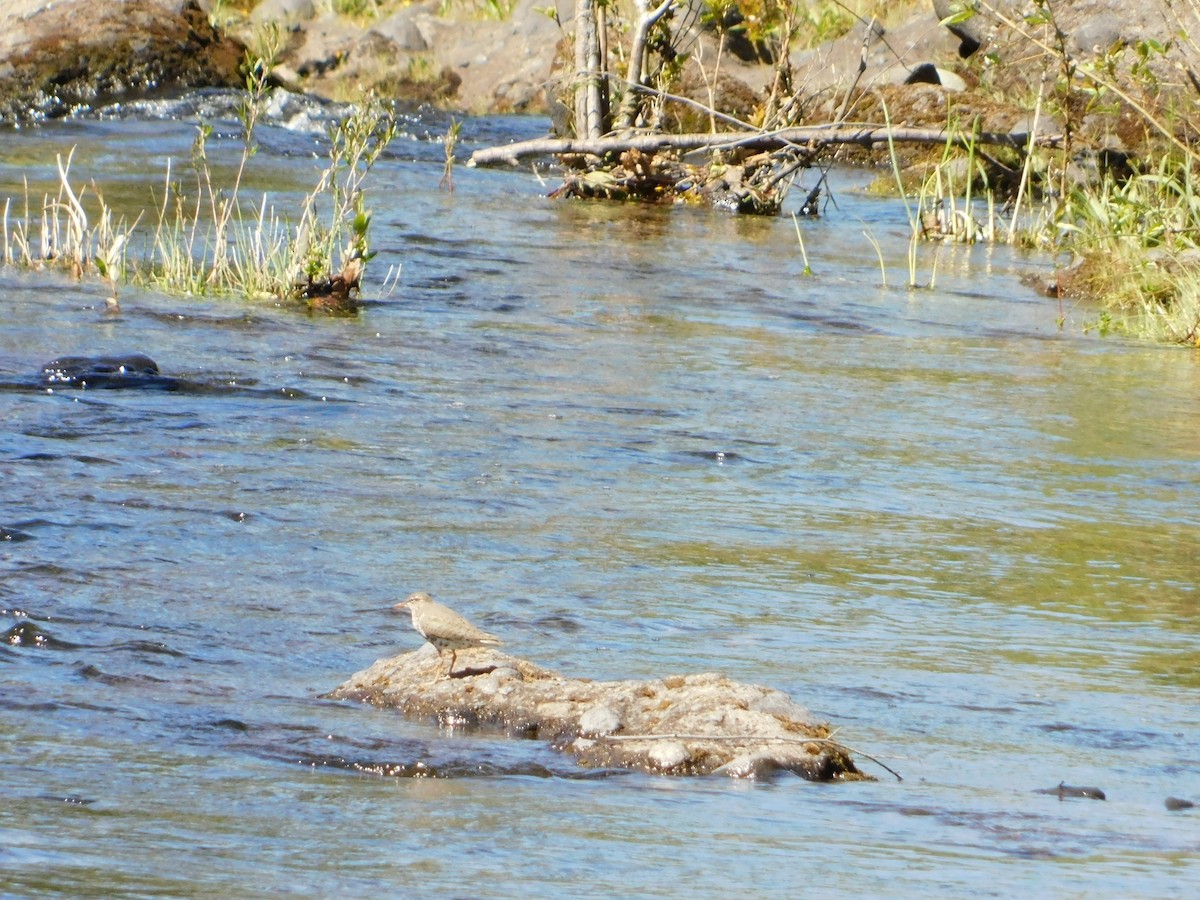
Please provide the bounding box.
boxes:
[328,644,886,781]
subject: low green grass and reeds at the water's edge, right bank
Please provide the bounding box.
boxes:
[877,128,1200,347]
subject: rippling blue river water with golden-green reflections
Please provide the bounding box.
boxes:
[0,98,1200,896]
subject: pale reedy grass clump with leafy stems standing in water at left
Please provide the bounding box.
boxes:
[0,45,396,311]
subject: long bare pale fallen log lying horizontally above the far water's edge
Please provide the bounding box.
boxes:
[467,125,1062,166]
